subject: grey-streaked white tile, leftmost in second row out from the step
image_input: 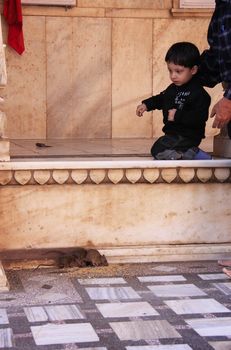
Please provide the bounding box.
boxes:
[86,287,141,300]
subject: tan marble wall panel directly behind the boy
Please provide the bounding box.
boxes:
[153,18,222,136]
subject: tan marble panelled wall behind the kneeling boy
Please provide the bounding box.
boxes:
[2,10,222,139]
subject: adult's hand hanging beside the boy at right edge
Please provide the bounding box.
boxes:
[210,97,231,129]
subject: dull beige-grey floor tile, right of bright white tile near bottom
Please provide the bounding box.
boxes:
[109,320,181,341]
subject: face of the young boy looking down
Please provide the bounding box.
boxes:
[167,62,198,86]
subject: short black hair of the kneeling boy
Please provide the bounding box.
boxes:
[165,41,200,68]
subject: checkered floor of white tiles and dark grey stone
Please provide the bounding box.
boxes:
[0,262,231,350]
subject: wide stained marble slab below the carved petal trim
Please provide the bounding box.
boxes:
[0,183,230,250]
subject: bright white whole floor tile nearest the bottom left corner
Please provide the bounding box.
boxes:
[30,323,99,345]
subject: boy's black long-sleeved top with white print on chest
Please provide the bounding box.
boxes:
[142,77,211,142]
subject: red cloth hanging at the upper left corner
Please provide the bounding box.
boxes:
[3,0,25,55]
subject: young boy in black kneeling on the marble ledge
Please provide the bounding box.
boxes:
[136,42,211,160]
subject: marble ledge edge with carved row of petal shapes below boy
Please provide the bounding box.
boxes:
[0,158,231,186]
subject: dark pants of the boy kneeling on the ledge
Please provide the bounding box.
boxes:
[151,135,199,158]
